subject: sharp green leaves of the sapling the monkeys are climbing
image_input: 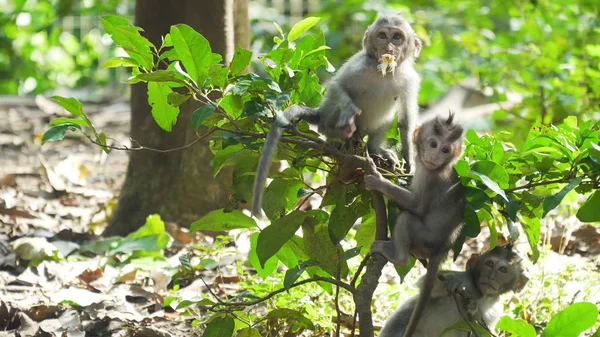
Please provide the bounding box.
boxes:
[39,10,600,336]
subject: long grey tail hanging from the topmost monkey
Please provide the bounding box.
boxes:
[252,105,319,216]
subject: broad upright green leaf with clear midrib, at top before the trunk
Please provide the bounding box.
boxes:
[170,24,213,84]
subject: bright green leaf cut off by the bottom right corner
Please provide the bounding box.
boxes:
[542,302,598,337]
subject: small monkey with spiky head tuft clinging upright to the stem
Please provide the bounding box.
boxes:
[364,112,466,337]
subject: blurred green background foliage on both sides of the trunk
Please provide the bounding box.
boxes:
[0,0,600,141]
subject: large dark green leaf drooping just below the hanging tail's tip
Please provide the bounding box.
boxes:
[256,211,306,268]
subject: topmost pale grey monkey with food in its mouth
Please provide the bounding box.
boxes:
[252,15,422,214]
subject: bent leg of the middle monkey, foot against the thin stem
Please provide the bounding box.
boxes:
[371,211,412,266]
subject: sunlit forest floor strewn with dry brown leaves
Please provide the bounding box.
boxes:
[0,97,600,337]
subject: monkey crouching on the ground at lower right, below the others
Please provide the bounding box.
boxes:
[379,244,529,337]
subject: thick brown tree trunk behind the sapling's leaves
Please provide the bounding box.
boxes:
[103,0,248,236]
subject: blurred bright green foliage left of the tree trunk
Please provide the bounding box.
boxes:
[0,0,126,95]
